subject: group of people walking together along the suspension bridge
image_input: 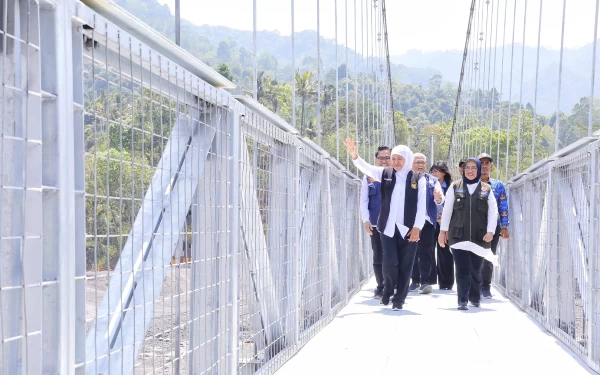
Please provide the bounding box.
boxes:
[352,138,509,310]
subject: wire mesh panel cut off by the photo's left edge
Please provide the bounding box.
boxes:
[0,0,43,374]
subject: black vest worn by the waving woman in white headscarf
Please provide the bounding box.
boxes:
[377,167,423,233]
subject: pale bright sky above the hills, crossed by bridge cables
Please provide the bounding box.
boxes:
[159,0,596,55]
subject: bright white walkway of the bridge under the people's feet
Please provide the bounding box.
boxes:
[276,281,594,375]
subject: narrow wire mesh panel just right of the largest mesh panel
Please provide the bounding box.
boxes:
[239,110,299,373]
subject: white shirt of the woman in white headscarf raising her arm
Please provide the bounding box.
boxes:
[352,157,427,238]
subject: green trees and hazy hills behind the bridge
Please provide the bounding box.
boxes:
[84,0,600,269]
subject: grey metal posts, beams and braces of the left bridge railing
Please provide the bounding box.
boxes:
[0,0,371,374]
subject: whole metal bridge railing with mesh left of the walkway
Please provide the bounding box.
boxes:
[0,0,371,374]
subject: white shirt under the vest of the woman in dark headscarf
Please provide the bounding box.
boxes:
[440,182,498,266]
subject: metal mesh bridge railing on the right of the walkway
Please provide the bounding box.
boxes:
[495,138,600,371]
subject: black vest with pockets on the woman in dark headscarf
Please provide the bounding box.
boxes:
[448,180,492,249]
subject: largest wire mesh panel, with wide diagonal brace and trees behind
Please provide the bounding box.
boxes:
[82,8,237,374]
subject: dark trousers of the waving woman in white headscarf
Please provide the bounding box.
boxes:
[381,227,418,304]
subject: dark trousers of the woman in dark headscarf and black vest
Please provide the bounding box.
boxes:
[452,249,483,303]
